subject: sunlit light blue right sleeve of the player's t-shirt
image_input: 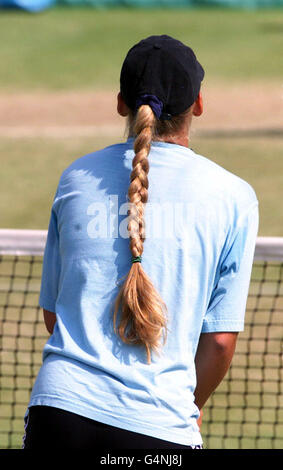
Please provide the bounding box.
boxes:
[202,203,258,333]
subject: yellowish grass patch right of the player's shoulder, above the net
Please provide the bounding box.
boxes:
[193,138,283,236]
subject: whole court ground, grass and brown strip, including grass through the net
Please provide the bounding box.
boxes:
[0,4,283,448]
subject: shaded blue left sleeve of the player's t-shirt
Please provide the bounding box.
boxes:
[39,202,61,313]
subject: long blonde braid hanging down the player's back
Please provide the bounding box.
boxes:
[113,105,166,363]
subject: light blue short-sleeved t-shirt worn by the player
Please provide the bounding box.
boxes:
[29,139,258,445]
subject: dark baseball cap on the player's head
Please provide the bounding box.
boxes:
[120,35,204,116]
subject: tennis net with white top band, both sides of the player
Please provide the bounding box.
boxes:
[0,230,283,449]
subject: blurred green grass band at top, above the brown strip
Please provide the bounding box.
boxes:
[0,8,283,91]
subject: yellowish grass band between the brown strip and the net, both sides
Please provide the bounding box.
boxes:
[0,134,283,236]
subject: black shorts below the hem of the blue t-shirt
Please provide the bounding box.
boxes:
[23,406,201,451]
